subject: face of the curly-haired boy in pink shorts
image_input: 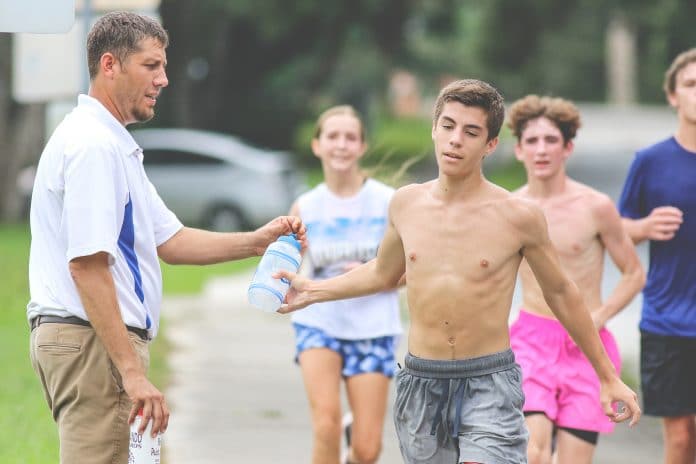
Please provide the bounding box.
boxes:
[515,117,573,179]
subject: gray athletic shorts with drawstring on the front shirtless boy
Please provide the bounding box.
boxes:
[394,350,528,464]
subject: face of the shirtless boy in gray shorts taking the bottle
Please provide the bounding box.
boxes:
[432,101,498,176]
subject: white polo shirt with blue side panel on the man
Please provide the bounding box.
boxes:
[27,95,183,337]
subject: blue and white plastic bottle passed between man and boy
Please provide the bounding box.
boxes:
[247,235,302,313]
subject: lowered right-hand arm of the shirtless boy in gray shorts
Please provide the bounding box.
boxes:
[519,204,641,425]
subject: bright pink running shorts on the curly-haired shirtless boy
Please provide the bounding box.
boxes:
[510,310,621,433]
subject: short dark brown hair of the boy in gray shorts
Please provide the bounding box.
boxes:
[433,79,505,140]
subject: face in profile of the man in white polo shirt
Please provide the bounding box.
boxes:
[113,39,169,125]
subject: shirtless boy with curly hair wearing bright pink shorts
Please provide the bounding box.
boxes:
[508,95,645,464]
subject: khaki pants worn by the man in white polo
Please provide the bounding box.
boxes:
[30,323,149,464]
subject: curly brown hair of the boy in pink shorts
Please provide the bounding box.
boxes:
[507,95,581,143]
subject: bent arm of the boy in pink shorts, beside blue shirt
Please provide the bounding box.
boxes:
[592,196,645,328]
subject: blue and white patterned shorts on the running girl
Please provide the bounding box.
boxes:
[292,323,399,378]
